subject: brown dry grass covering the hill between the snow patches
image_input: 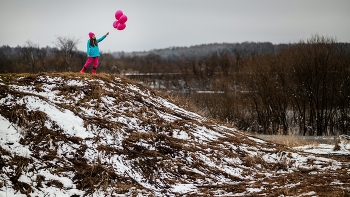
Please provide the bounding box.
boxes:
[0,73,349,196]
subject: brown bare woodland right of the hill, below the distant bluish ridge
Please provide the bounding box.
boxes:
[124,35,350,136]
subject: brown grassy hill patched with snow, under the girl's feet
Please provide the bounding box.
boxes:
[0,73,350,197]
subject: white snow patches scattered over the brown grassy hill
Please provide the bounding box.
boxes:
[0,74,350,197]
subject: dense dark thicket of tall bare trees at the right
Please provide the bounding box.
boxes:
[242,36,350,136]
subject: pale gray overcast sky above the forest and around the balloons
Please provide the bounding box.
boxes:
[0,0,350,52]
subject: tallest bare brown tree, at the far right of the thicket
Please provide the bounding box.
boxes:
[290,35,348,135]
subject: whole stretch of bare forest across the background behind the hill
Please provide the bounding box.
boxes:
[0,35,350,136]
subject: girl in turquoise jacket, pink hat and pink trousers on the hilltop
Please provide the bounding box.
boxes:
[80,32,109,75]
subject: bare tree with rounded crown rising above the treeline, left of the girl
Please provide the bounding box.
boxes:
[55,36,80,71]
